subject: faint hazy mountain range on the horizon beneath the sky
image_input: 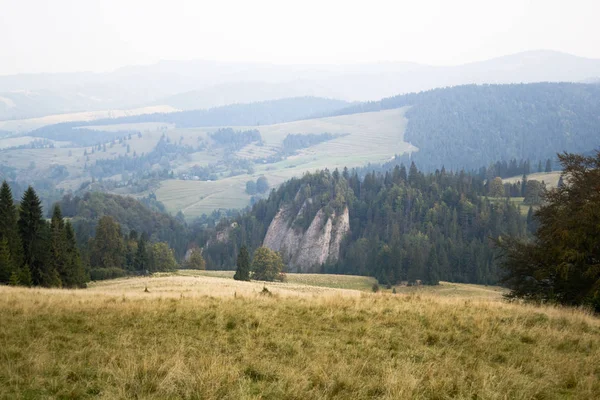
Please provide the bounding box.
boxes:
[0,50,600,120]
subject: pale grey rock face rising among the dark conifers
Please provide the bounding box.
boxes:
[263,203,350,272]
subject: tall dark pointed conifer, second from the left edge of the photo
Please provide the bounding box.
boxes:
[18,186,53,286]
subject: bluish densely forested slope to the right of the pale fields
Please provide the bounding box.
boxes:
[333,83,600,170]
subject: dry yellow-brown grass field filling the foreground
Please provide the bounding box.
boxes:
[0,271,600,399]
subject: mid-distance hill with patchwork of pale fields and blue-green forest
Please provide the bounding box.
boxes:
[0,83,600,219]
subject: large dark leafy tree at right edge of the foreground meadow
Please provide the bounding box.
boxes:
[499,151,600,312]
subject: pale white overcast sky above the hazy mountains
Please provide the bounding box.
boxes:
[0,0,600,75]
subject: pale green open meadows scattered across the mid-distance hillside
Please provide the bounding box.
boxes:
[0,108,417,219]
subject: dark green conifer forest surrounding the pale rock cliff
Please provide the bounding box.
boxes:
[200,164,527,284]
